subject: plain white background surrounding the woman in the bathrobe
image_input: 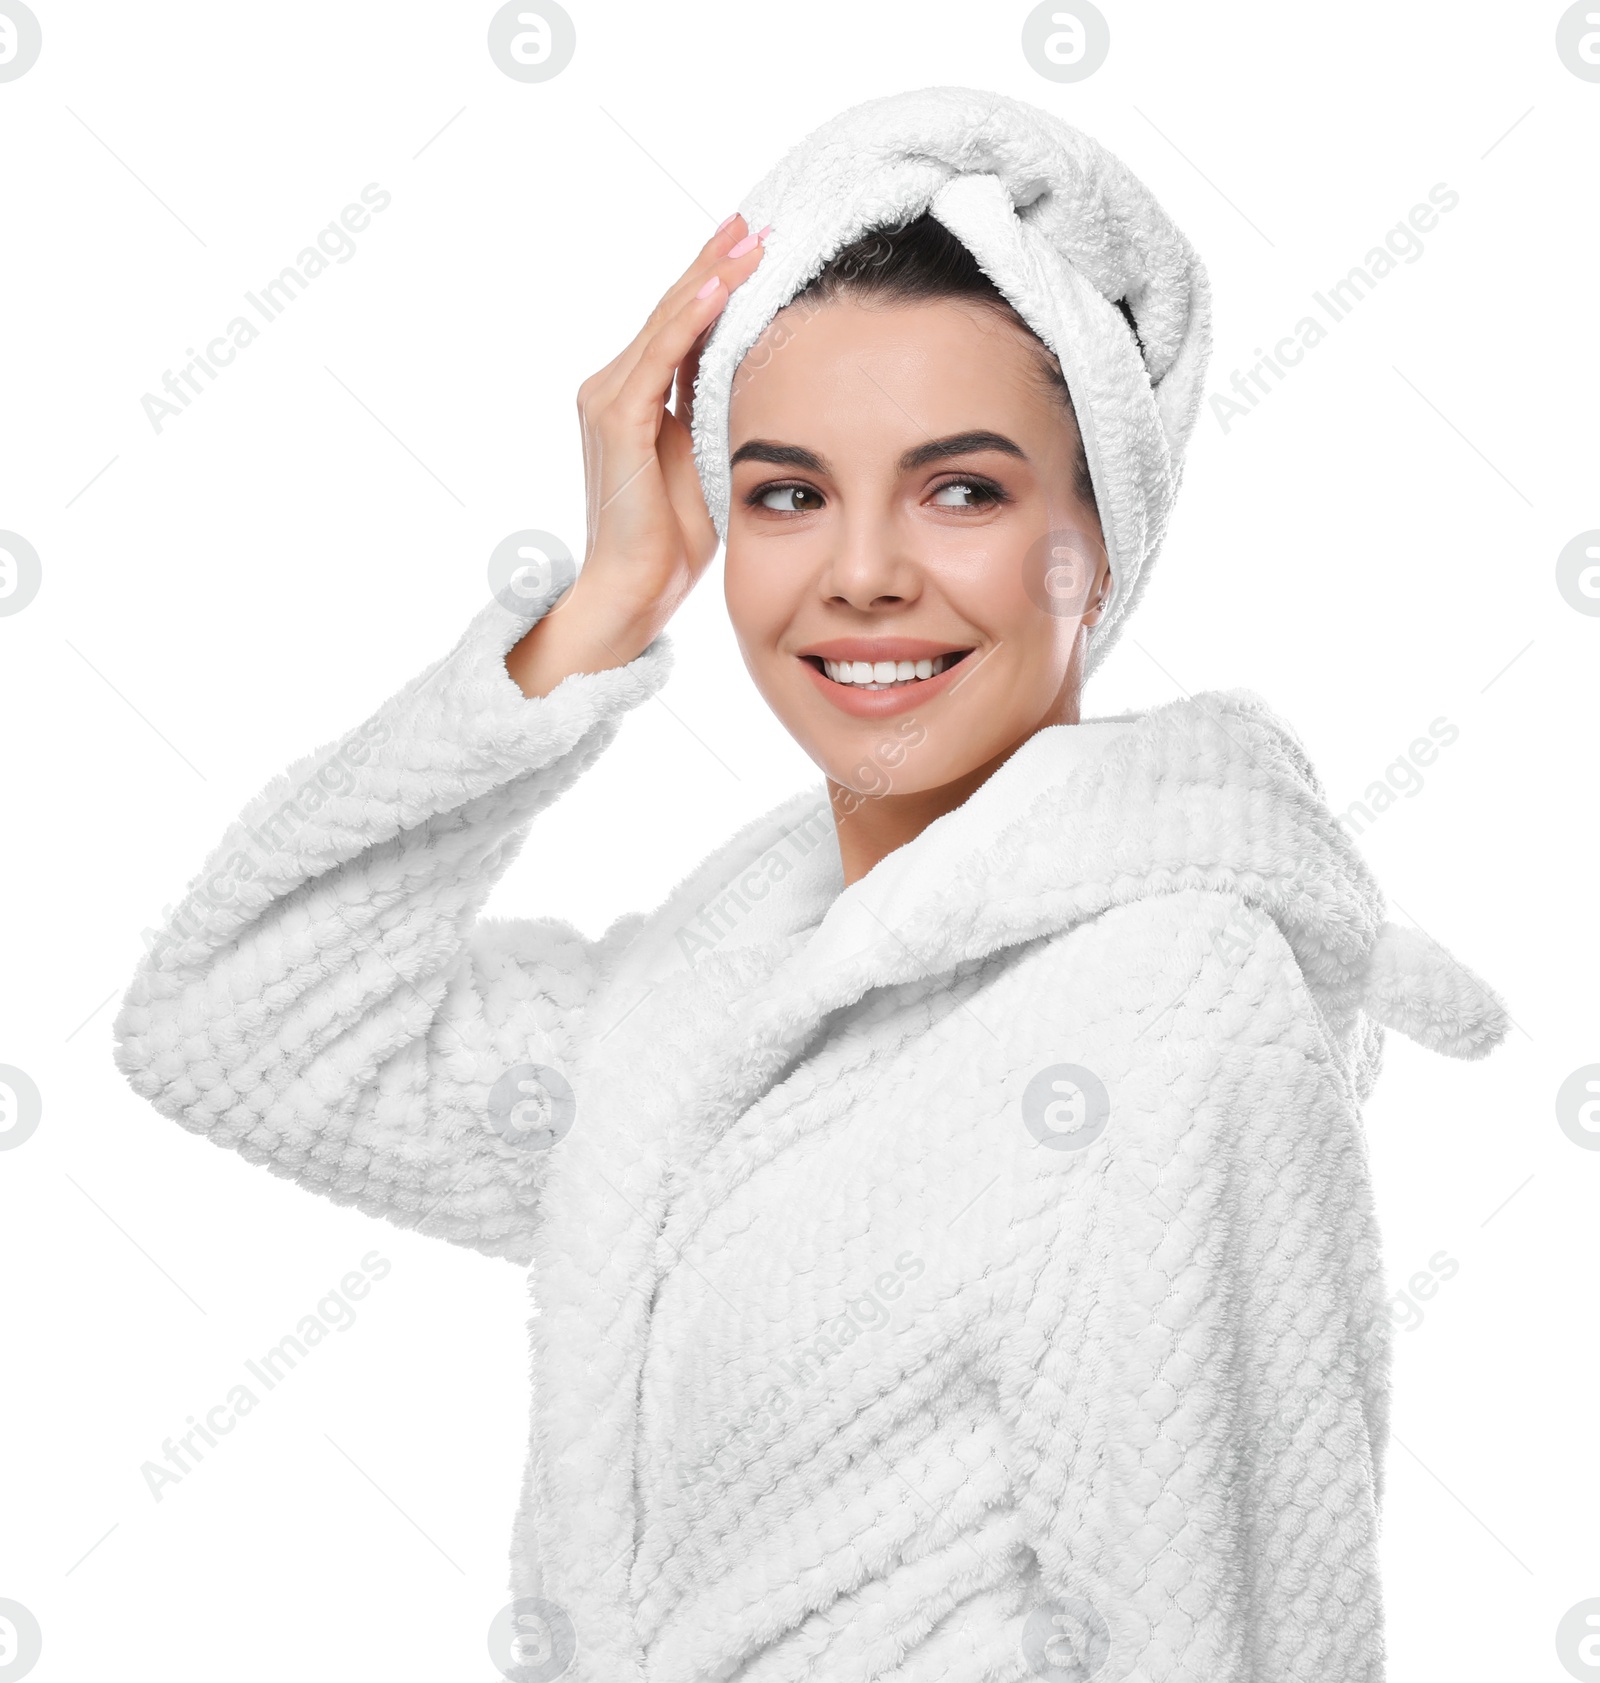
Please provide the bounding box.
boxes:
[0,0,1600,1683]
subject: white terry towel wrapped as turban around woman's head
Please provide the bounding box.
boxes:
[693,88,1211,673]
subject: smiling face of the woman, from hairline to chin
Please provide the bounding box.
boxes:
[725,298,1105,794]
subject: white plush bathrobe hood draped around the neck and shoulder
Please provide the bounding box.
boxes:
[598,688,1506,1077]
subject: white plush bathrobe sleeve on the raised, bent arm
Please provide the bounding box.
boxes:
[113,601,671,1264]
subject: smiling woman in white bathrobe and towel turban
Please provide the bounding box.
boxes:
[116,89,1504,1683]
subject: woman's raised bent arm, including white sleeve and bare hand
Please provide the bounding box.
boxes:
[114,207,777,1262]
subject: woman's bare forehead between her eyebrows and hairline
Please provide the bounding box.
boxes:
[728,296,1062,449]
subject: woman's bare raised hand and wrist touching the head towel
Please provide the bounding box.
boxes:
[506,214,767,697]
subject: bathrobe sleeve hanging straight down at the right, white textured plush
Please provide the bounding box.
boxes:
[1013,905,1390,1683]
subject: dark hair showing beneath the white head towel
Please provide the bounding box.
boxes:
[791,210,1139,518]
